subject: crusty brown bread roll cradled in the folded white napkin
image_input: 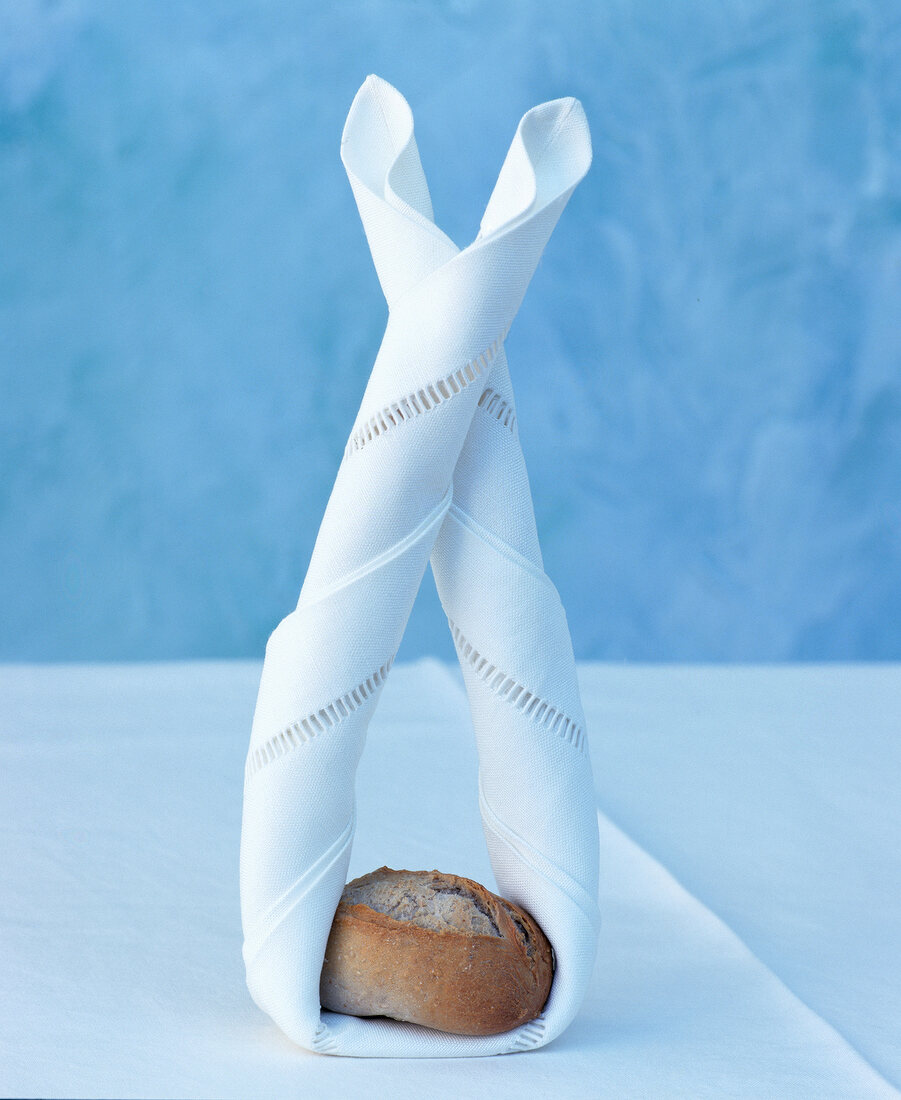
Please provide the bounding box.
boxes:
[319,867,553,1035]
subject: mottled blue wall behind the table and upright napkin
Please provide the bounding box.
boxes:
[0,0,901,661]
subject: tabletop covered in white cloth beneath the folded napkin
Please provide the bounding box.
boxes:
[0,660,901,1100]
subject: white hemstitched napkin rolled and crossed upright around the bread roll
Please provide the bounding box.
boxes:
[240,76,600,1057]
